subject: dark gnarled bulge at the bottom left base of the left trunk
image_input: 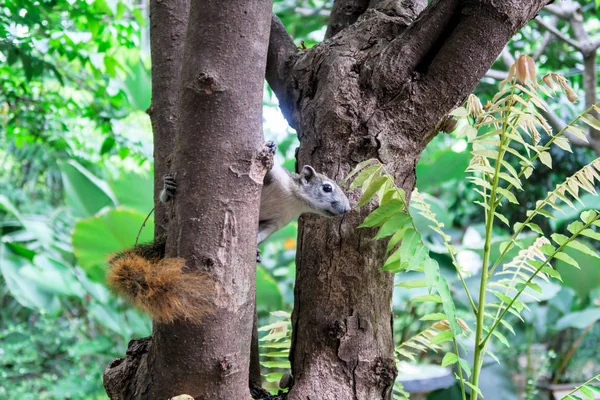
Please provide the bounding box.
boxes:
[103,336,152,400]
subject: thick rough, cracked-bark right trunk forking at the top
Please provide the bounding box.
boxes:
[267,0,548,400]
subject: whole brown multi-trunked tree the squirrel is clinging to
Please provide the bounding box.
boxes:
[104,0,551,400]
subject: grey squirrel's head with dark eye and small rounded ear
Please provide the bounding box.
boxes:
[299,165,350,217]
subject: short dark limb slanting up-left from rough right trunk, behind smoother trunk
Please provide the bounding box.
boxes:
[265,14,298,127]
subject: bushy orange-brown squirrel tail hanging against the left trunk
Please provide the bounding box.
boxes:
[107,247,214,323]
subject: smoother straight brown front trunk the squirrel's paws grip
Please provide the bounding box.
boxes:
[105,0,272,399]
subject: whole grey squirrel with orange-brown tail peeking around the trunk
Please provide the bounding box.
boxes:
[107,141,350,323]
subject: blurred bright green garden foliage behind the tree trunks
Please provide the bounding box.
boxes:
[0,0,600,399]
